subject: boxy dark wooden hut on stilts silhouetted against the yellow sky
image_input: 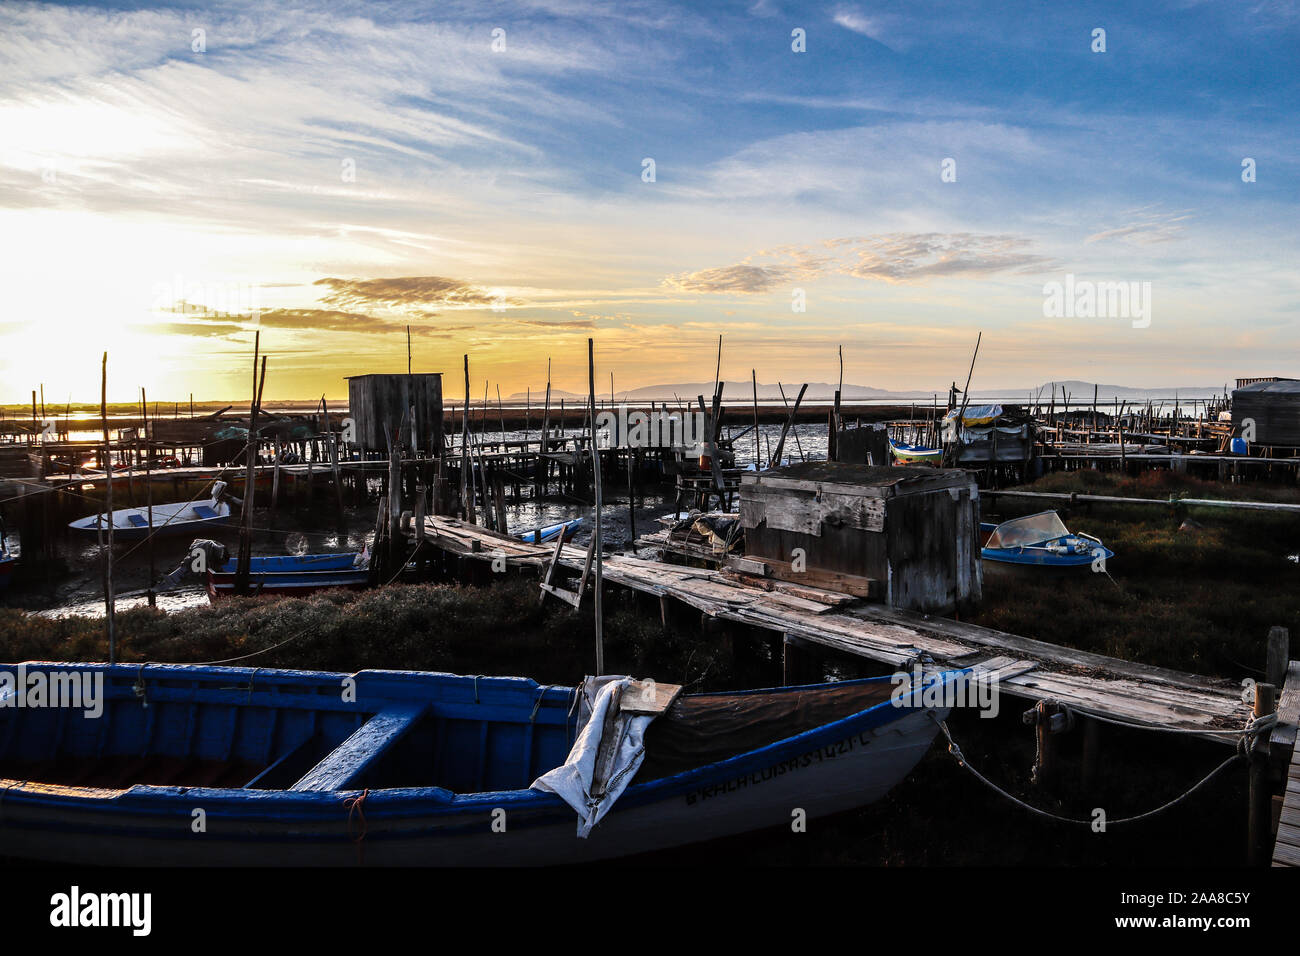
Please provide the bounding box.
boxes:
[347,372,442,453]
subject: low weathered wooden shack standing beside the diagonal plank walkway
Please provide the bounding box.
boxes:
[740,462,983,614]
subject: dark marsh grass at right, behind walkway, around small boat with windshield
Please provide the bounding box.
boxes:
[969,471,1300,678]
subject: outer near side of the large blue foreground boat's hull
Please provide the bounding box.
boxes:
[0,711,946,866]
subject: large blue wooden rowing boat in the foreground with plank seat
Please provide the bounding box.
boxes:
[0,663,961,866]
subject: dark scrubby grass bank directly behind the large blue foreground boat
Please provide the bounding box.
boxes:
[0,578,729,685]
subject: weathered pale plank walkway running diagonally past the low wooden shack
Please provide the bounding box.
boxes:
[424,516,1251,747]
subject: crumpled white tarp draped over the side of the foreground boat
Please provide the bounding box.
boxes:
[532,676,654,838]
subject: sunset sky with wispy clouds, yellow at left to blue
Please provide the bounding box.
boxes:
[0,0,1300,403]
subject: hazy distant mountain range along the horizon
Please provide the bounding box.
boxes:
[506,380,1223,405]
